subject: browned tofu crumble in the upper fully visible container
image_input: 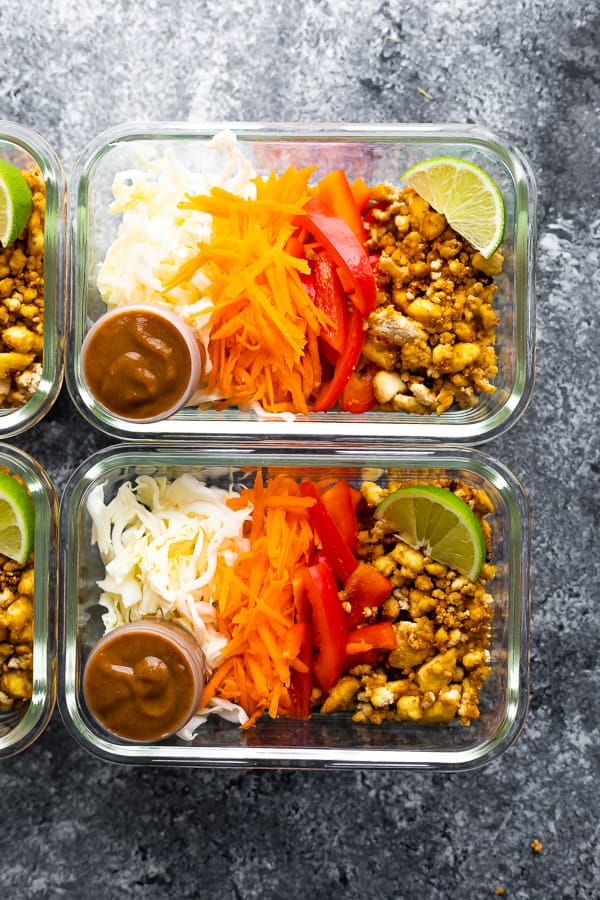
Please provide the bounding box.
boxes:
[363,183,503,415]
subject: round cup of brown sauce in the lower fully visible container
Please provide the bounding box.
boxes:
[83,619,204,743]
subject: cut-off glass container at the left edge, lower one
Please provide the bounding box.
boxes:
[0,443,58,760]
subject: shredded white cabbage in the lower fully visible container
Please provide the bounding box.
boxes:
[87,474,251,739]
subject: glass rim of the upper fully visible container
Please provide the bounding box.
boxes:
[66,120,537,445]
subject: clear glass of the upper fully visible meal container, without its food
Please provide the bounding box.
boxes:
[67,123,536,444]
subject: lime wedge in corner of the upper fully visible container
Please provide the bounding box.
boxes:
[402,156,504,259]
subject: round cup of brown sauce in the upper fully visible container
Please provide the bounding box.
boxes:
[82,305,198,421]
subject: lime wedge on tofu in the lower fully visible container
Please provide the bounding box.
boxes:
[375,485,485,581]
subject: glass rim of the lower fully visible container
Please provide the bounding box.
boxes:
[58,441,530,771]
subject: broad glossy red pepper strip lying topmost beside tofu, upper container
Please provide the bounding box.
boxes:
[302,197,377,317]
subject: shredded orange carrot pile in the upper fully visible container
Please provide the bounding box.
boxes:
[173,167,327,413]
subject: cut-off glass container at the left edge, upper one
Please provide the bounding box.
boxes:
[0,120,65,438]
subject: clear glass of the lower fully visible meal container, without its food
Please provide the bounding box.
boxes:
[59,442,529,770]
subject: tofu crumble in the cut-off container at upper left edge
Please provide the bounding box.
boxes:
[0,171,46,409]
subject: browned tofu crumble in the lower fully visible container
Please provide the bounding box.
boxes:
[321,479,495,725]
